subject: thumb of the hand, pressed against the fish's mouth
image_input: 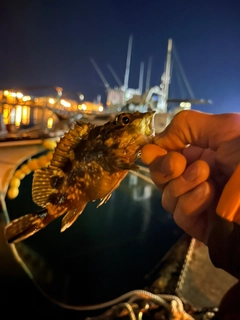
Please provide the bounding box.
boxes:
[154,110,240,150]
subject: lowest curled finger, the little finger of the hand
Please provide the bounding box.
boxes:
[173,181,216,241]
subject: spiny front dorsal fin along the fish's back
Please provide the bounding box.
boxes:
[49,121,95,170]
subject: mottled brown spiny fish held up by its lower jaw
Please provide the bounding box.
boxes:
[5,111,155,244]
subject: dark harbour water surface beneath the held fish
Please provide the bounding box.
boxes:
[6,165,182,306]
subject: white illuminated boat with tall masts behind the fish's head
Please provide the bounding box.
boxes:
[90,36,212,132]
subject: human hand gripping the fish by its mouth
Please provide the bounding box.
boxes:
[142,110,240,244]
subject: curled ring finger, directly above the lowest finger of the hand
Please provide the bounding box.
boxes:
[162,160,210,213]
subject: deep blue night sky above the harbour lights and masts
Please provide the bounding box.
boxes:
[0,0,240,113]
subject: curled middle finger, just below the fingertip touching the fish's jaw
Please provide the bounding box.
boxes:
[149,151,187,190]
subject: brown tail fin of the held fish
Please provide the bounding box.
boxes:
[5,209,47,244]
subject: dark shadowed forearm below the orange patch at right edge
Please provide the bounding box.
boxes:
[208,217,240,279]
